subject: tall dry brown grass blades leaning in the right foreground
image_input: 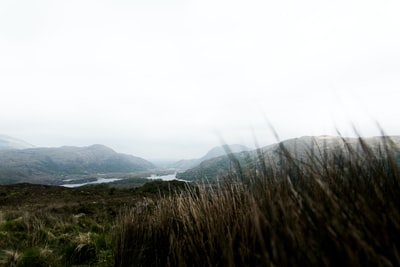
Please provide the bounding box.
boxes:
[115,138,400,266]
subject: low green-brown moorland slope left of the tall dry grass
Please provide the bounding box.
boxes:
[0,180,190,266]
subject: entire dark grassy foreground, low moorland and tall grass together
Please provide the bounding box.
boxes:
[0,139,400,266]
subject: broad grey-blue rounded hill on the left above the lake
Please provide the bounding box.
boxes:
[0,145,155,184]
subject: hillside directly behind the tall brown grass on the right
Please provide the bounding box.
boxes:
[177,136,400,181]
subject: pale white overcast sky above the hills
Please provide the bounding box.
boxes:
[0,0,400,159]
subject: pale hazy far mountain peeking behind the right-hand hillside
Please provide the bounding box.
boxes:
[169,144,250,171]
